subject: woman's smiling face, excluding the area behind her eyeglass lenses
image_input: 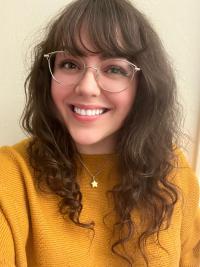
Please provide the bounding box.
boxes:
[51,39,137,154]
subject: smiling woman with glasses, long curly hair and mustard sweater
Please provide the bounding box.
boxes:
[0,0,200,267]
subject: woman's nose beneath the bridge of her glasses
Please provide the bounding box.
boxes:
[75,67,101,97]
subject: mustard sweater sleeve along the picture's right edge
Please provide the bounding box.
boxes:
[179,153,200,267]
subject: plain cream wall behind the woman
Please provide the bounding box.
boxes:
[0,0,200,178]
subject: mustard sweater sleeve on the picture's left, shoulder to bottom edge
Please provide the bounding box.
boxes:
[0,147,28,267]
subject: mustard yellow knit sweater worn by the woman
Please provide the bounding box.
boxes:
[0,141,200,267]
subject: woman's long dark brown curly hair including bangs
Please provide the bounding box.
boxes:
[22,0,180,266]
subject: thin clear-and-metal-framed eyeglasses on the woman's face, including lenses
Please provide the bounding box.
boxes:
[44,51,140,93]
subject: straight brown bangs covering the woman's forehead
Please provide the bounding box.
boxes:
[48,0,143,59]
